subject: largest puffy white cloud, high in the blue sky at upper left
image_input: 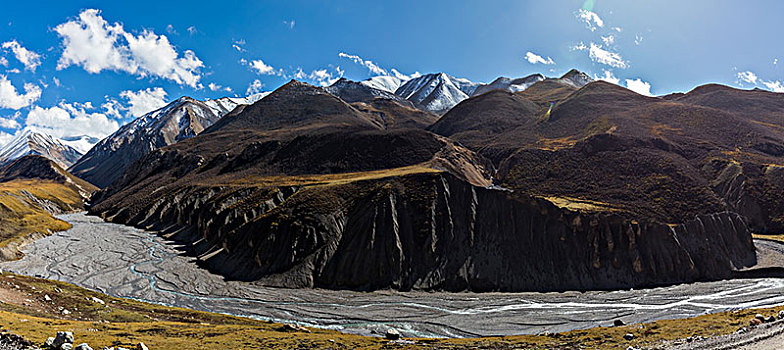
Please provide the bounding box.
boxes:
[54,9,204,88]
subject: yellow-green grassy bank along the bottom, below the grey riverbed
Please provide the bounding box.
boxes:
[0,273,777,349]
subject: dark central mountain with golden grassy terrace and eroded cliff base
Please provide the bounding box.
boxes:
[91,82,755,291]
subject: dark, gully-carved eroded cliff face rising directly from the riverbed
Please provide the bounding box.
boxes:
[92,173,756,291]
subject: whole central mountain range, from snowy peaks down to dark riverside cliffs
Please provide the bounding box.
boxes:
[3,70,784,291]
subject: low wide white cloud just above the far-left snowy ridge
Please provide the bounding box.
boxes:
[25,102,119,138]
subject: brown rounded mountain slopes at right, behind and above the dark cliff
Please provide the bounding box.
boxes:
[432,81,784,232]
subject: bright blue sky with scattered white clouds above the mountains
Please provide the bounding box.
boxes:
[0,0,784,144]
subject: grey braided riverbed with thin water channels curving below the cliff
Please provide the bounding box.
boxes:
[0,214,784,337]
